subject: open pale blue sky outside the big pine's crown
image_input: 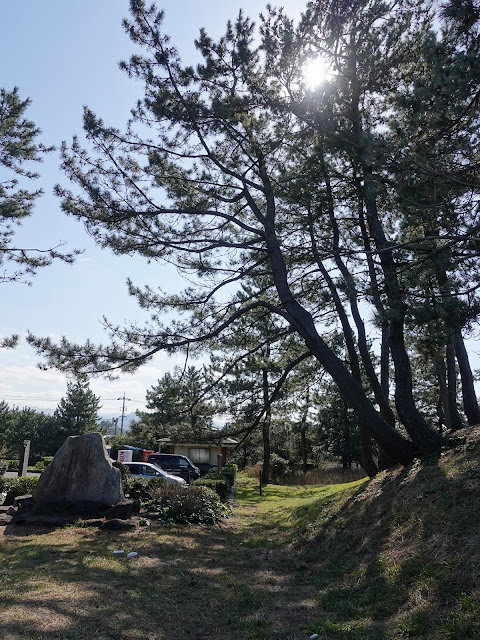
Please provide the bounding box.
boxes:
[0,0,304,414]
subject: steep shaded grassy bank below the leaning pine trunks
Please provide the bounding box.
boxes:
[284,428,480,640]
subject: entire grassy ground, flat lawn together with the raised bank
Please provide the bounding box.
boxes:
[0,429,480,640]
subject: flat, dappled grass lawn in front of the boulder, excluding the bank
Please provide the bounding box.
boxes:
[0,480,362,640]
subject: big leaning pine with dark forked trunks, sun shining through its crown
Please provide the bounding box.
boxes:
[31,0,478,470]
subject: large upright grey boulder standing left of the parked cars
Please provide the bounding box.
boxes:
[33,433,124,511]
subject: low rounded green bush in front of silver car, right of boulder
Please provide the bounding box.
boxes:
[145,484,230,524]
